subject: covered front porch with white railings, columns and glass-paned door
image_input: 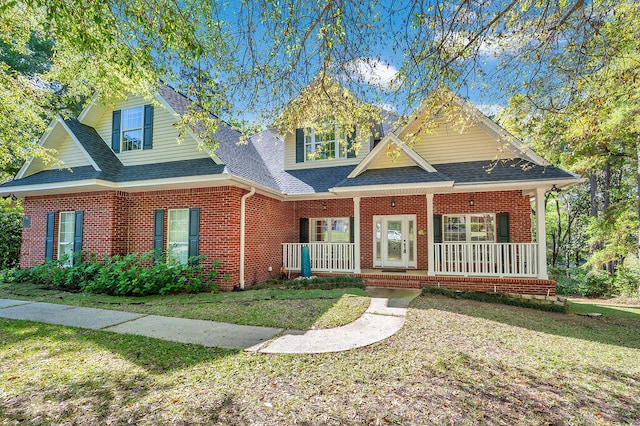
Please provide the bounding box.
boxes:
[282,188,548,282]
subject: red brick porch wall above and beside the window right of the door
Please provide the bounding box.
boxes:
[433,191,531,243]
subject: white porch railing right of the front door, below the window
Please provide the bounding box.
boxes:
[434,242,538,277]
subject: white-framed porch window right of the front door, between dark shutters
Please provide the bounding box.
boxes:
[443,213,496,242]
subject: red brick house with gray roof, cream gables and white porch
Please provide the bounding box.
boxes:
[0,85,581,295]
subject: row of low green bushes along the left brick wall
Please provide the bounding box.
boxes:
[3,252,219,296]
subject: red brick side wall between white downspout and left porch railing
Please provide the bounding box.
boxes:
[244,194,299,286]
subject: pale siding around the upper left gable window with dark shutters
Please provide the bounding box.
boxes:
[95,97,209,166]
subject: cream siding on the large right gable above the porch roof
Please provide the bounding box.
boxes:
[400,121,514,168]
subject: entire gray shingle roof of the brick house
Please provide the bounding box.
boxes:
[2,84,575,195]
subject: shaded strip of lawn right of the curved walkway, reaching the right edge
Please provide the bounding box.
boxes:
[411,295,640,349]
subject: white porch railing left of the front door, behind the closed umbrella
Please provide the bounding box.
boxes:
[282,243,355,272]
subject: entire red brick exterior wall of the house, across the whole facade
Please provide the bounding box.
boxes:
[21,187,548,294]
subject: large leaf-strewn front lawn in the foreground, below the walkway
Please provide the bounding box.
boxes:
[0,295,640,425]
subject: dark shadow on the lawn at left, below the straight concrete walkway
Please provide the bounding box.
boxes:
[0,319,240,374]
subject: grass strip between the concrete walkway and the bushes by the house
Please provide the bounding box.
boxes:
[0,283,369,330]
